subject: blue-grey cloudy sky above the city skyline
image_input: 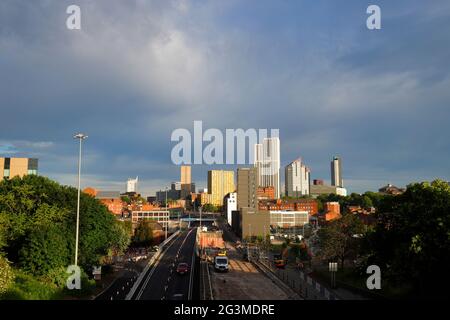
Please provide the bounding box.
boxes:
[0,0,450,195]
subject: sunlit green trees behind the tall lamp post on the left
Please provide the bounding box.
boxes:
[0,175,131,297]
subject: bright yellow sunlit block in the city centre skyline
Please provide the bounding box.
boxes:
[208,170,236,206]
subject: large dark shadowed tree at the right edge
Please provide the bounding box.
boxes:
[363,180,450,294]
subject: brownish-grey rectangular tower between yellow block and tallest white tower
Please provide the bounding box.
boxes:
[237,168,258,210]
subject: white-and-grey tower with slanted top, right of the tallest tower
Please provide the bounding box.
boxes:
[284,158,311,198]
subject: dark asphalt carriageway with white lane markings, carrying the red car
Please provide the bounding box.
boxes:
[136,228,196,300]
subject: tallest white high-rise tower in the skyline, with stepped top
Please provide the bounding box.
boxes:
[254,137,280,199]
